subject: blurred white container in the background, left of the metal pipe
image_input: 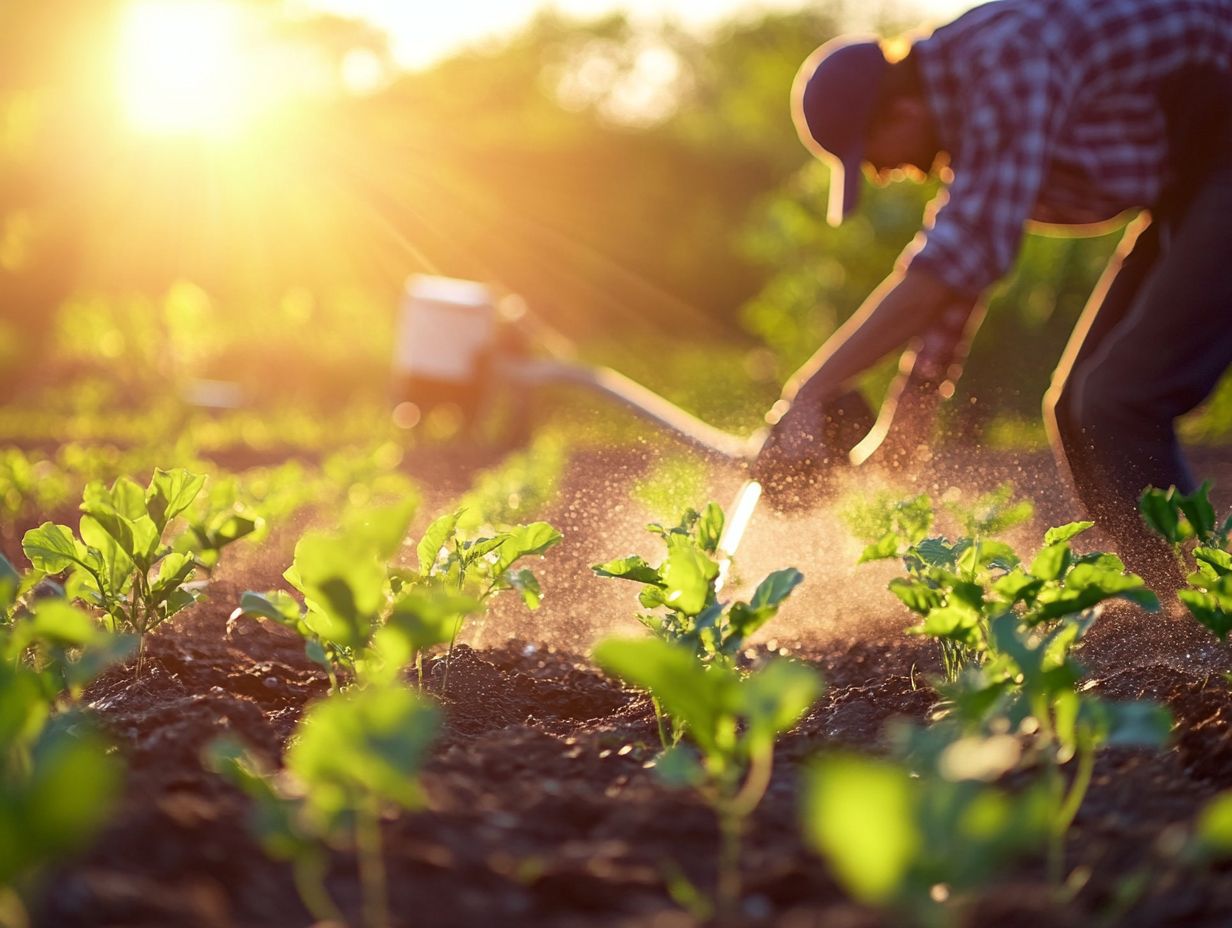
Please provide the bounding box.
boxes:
[393,275,496,383]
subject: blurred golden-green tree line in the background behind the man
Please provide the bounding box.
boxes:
[0,0,1222,433]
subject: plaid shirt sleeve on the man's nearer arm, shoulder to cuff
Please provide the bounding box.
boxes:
[903,47,1064,296]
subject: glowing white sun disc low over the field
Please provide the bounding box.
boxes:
[118,0,253,136]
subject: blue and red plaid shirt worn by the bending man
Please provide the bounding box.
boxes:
[904,0,1232,295]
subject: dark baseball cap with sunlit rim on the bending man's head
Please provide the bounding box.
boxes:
[791,36,890,226]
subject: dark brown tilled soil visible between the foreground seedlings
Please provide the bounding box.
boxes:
[19,446,1232,928]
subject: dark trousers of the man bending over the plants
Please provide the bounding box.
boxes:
[1045,158,1232,585]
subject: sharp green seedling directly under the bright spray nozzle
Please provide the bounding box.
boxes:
[590,503,804,665]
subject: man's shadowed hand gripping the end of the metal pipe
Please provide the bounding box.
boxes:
[752,389,875,510]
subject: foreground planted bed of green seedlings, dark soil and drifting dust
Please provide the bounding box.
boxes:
[7,411,1232,927]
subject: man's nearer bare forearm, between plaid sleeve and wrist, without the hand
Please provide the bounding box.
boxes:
[784,263,976,399]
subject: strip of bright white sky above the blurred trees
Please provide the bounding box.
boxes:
[301,0,977,68]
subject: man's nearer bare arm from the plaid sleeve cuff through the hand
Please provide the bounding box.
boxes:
[755,269,977,477]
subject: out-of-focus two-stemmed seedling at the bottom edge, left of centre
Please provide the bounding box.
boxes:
[207,683,440,928]
